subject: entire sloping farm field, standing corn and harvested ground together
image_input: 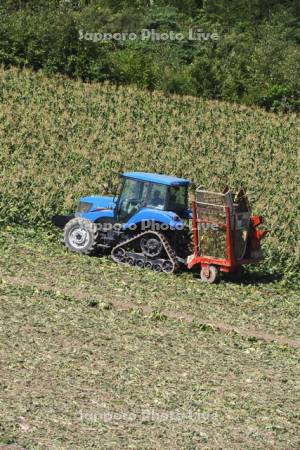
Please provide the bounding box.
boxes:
[0,69,300,450]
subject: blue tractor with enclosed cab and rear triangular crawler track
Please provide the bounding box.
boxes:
[53,172,192,273]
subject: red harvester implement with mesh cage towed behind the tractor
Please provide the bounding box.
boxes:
[187,189,268,283]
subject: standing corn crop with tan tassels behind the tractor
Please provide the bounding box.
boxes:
[0,69,299,279]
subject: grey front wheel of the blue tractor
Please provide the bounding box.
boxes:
[64,217,98,255]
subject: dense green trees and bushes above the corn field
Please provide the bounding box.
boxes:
[0,0,300,111]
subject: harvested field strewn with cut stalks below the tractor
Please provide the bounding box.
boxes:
[0,228,300,450]
